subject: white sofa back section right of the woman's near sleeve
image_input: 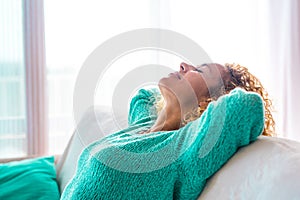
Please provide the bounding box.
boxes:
[199,136,300,200]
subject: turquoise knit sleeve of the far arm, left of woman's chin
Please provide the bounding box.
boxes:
[128,88,160,126]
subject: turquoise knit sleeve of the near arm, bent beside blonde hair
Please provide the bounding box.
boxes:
[174,89,264,199]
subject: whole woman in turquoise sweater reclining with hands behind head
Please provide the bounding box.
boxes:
[62,63,274,199]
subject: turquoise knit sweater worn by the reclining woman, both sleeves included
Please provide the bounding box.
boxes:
[61,89,264,200]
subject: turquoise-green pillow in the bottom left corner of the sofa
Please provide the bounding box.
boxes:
[0,156,60,200]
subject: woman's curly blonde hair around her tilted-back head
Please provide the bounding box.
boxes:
[156,63,276,136]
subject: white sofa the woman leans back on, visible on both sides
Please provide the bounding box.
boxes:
[0,106,300,200]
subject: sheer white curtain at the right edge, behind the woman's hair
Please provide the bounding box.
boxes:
[268,0,300,140]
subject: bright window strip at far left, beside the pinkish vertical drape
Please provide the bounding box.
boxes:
[0,0,27,158]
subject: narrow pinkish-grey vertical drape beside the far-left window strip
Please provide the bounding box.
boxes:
[23,0,48,155]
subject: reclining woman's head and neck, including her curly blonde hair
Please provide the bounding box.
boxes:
[147,63,275,136]
